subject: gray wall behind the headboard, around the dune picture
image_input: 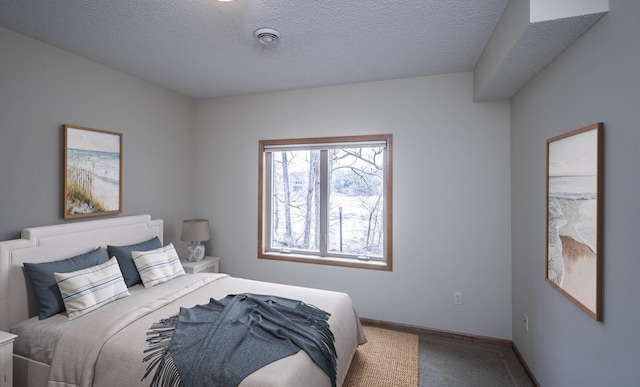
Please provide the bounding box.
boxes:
[0,28,194,246]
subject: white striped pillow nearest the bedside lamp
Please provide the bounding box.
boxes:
[131,243,185,289]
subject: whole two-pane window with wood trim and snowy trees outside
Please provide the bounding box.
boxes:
[258,135,392,270]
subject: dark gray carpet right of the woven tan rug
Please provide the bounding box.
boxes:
[420,336,533,387]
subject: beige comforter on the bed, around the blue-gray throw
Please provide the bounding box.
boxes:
[49,274,366,387]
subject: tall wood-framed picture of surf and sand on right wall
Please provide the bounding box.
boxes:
[546,123,603,321]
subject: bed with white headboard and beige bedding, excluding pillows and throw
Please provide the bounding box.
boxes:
[0,215,366,387]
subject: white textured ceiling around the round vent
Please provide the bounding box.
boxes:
[0,0,508,98]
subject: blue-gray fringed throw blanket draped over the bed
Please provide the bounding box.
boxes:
[142,293,337,387]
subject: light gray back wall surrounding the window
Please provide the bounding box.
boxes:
[195,73,511,339]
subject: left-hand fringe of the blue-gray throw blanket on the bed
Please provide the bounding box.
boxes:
[140,315,182,387]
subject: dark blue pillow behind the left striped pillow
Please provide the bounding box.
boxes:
[24,247,104,320]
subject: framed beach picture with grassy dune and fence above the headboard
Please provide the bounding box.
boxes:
[63,125,122,219]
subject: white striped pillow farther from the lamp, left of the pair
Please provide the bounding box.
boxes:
[54,257,129,320]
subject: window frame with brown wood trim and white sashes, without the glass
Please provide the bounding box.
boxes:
[258,134,393,271]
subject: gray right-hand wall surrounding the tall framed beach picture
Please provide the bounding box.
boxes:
[511,0,640,386]
